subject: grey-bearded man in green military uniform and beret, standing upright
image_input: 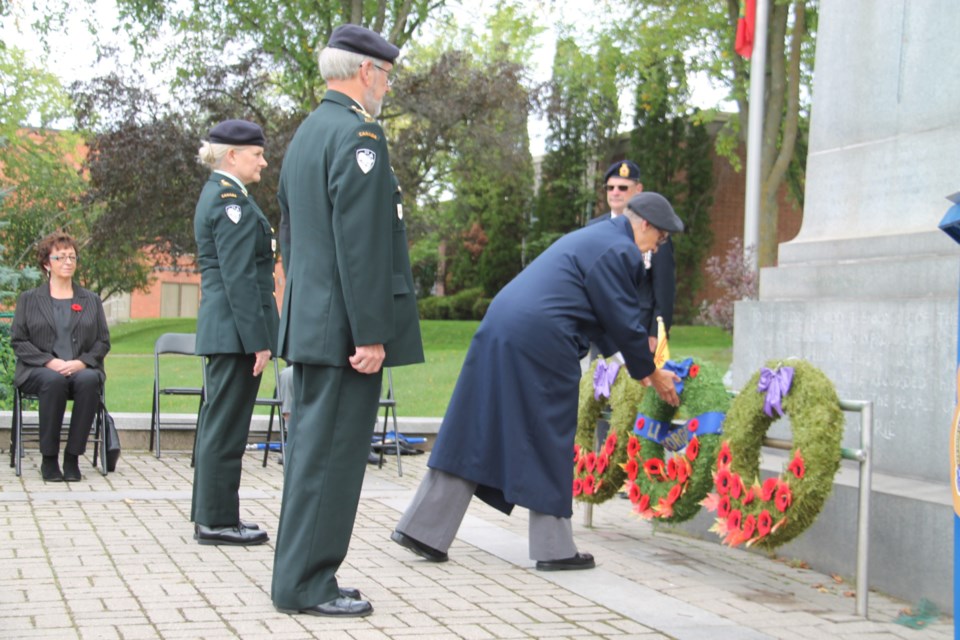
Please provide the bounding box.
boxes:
[272,25,423,616]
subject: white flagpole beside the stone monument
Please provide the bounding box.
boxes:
[743,0,770,271]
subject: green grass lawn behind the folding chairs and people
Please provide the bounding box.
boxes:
[106,318,732,417]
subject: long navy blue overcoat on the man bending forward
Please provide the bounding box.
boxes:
[429,216,655,518]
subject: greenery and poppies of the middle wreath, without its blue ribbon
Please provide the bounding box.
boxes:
[625,360,730,523]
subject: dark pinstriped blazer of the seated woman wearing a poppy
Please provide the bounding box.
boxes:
[10,282,110,386]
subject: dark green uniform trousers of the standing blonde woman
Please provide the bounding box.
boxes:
[190,353,262,527]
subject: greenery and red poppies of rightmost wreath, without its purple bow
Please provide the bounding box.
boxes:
[704,360,844,550]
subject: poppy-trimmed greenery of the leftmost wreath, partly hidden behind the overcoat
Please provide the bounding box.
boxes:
[573,359,645,504]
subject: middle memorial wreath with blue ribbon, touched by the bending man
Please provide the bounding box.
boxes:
[624,359,730,522]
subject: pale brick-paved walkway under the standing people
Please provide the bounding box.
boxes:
[0,452,953,640]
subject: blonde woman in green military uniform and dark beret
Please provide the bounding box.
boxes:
[191,120,278,545]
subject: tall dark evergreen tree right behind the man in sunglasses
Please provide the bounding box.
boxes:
[629,56,713,322]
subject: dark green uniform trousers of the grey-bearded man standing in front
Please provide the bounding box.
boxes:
[272,363,383,609]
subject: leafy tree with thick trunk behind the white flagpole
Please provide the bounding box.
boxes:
[609,0,818,266]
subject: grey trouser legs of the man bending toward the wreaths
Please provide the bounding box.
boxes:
[397,468,577,560]
